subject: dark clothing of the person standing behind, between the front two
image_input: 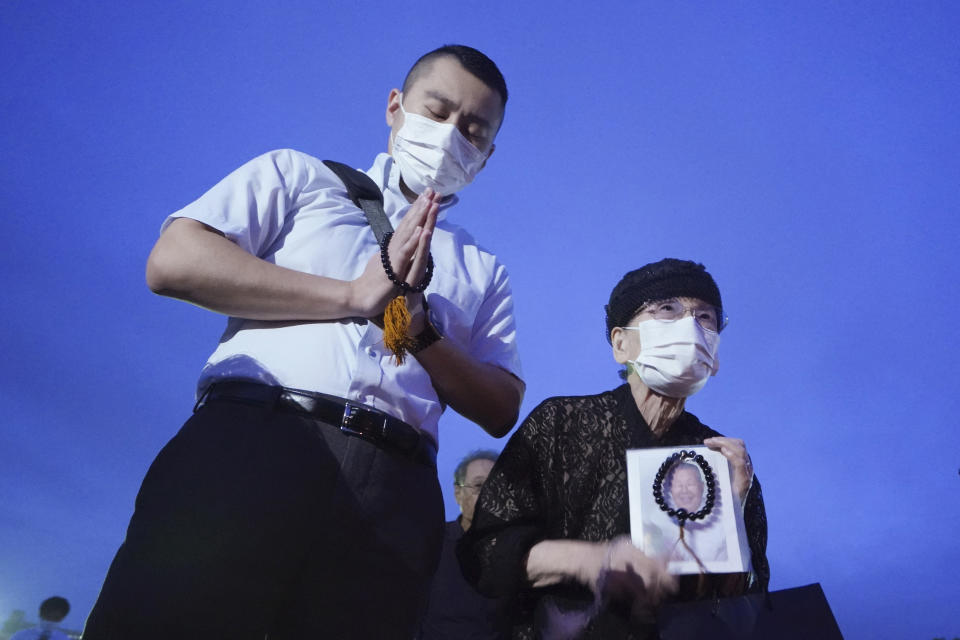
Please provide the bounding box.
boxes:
[418,518,508,640]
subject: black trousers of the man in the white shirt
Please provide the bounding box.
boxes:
[83,401,444,640]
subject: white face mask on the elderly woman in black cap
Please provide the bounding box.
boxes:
[625,316,720,398]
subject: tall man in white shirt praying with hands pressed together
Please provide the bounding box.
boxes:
[84,45,524,640]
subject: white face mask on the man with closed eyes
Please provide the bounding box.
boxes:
[392,96,488,196]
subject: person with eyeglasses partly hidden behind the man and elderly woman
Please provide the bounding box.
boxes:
[417,449,509,640]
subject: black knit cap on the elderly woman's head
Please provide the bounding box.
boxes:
[604,258,723,342]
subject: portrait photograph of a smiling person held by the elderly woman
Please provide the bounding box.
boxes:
[627,446,750,574]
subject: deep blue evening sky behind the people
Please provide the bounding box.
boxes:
[0,0,960,639]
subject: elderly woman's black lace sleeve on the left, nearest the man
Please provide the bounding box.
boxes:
[457,401,556,597]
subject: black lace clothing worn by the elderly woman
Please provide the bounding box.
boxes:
[459,385,770,640]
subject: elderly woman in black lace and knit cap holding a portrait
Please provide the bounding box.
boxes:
[459,258,769,640]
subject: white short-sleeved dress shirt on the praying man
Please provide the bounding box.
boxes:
[164,149,521,442]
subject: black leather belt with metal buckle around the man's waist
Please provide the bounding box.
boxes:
[197,380,437,467]
